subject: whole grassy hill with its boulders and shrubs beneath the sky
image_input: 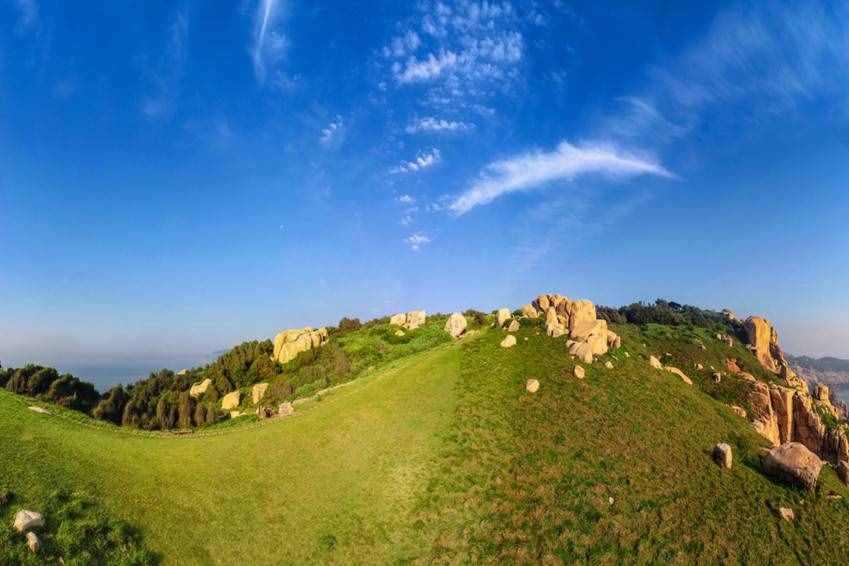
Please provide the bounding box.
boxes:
[0,295,849,564]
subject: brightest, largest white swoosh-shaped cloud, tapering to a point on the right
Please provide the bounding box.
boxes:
[449,141,675,215]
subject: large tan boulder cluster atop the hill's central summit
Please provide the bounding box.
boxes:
[522,294,622,363]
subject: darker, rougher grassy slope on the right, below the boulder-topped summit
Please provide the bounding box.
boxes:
[406,327,849,563]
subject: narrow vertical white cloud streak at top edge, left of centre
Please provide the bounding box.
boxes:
[251,0,289,85]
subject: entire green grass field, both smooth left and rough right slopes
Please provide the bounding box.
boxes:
[0,324,849,564]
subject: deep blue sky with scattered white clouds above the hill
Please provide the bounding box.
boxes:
[0,0,849,386]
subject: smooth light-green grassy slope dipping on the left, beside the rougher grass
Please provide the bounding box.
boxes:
[0,346,459,564]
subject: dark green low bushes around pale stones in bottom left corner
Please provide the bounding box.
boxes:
[0,490,159,566]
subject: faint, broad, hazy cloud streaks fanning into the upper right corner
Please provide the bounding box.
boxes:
[602,1,849,144]
